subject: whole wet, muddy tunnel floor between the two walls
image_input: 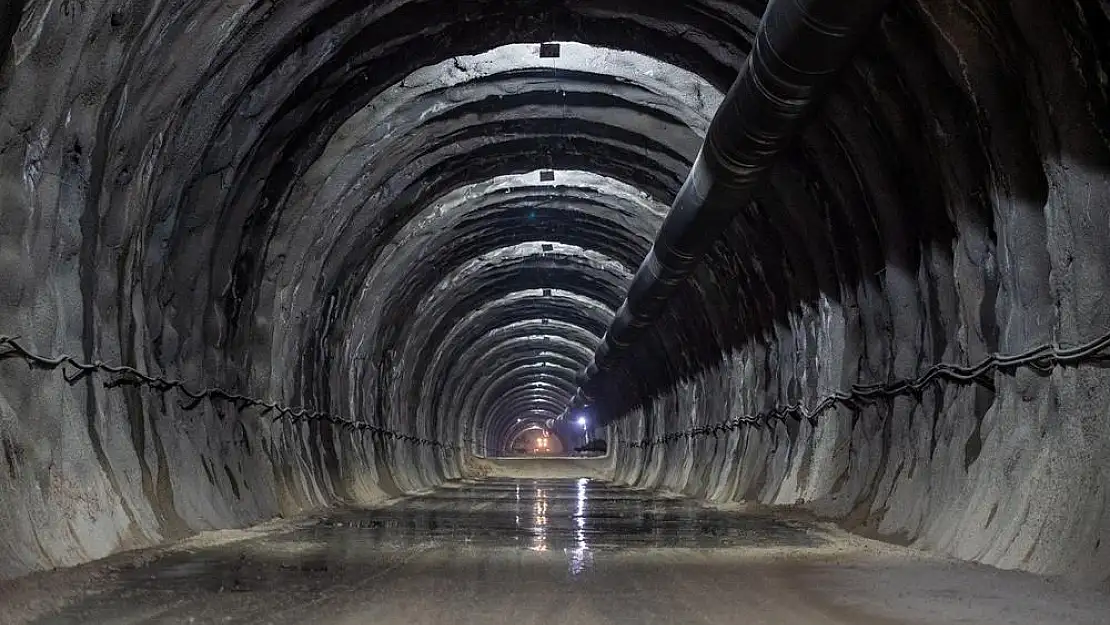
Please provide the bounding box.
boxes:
[0,477,1110,625]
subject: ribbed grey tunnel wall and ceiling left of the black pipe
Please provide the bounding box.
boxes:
[0,0,728,577]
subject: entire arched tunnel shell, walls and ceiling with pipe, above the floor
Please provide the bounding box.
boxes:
[0,0,1110,624]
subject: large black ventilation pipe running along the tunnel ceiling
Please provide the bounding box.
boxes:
[563,0,890,417]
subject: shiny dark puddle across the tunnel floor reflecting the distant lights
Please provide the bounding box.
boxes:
[308,478,815,552]
